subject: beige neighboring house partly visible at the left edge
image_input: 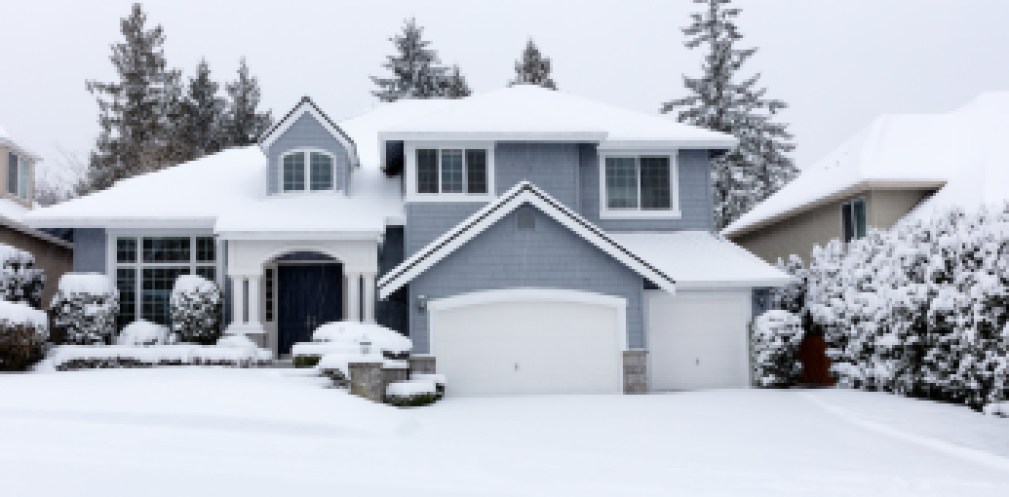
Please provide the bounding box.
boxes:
[0,123,74,305]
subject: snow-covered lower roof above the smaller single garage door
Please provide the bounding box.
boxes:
[610,231,791,288]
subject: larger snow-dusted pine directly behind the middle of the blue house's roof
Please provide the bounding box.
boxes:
[371,18,450,102]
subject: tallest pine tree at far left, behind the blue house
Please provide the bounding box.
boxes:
[85,4,182,191]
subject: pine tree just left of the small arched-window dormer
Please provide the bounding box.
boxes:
[221,57,273,148]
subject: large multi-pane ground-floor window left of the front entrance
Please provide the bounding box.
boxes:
[109,234,218,329]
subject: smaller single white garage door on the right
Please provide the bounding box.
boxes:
[646,290,751,390]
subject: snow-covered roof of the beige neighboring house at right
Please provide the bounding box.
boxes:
[722,92,1009,235]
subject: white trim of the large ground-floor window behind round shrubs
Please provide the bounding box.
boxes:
[105,230,224,325]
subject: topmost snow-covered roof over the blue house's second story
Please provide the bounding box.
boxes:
[381,85,736,148]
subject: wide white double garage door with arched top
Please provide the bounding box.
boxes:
[429,289,627,395]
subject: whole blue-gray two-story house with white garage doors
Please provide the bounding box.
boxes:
[31,86,788,394]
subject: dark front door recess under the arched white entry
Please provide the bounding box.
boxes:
[263,251,346,356]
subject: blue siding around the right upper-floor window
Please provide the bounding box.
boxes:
[578,145,714,232]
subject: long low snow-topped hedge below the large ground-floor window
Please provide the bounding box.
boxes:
[41,344,269,371]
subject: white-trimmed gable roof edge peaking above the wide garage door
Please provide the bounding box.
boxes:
[378,181,676,298]
